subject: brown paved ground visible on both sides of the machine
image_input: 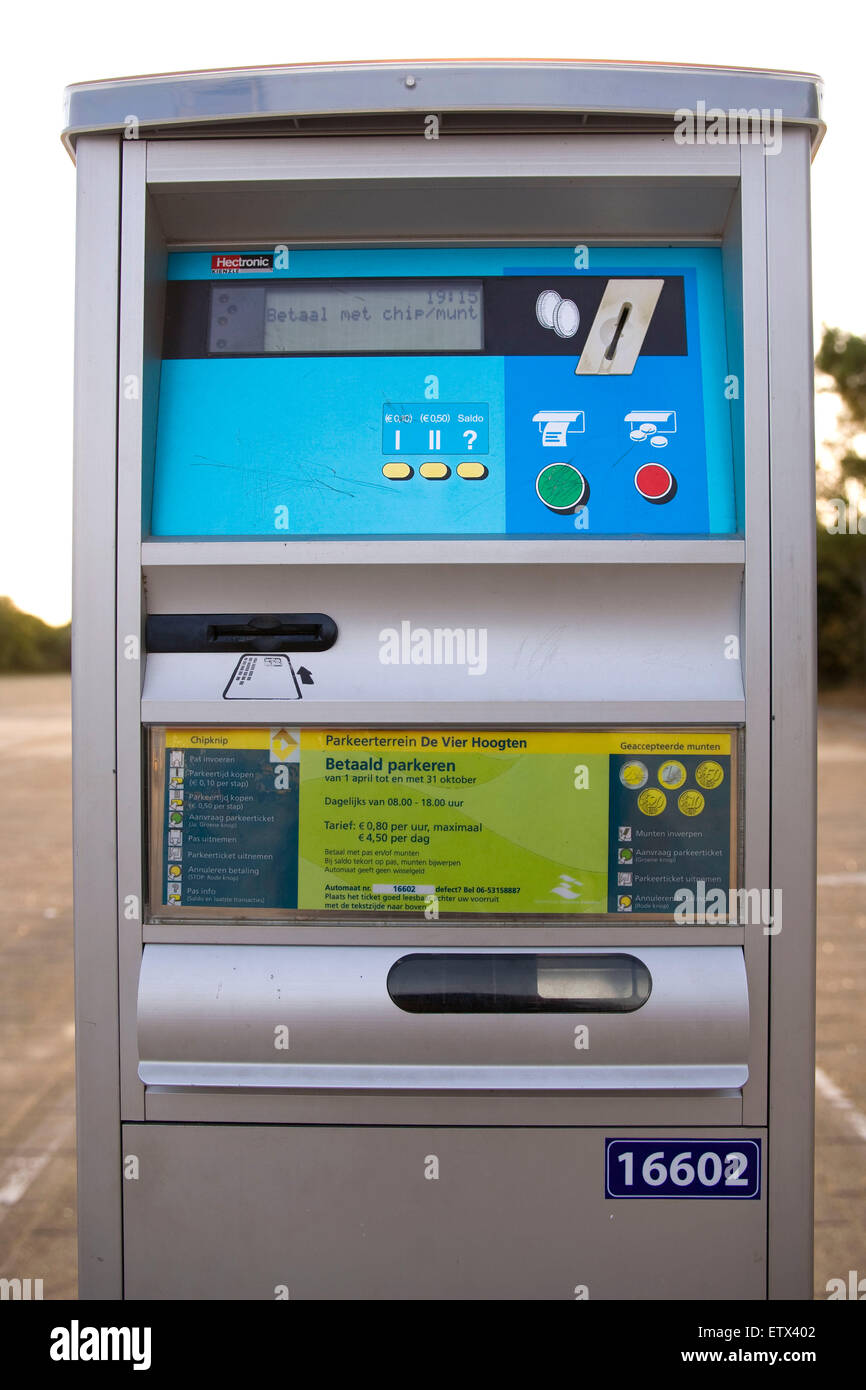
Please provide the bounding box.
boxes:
[0,676,866,1298]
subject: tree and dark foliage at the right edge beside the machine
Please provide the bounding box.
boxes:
[815,328,866,685]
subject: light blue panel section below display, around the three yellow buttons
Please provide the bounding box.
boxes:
[152,357,505,538]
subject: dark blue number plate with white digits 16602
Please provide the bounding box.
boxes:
[605,1138,760,1198]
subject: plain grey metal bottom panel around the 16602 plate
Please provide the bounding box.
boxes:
[124,1102,766,1301]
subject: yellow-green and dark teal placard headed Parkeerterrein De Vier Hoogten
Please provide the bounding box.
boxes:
[154,727,735,919]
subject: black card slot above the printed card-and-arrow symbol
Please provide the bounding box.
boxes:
[146,613,336,652]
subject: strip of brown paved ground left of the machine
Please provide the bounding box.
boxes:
[0,676,75,1298]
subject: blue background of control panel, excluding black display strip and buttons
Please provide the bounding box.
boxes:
[161,246,737,535]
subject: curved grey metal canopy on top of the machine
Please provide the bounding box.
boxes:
[63,60,824,156]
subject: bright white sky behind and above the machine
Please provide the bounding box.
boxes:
[0,0,866,623]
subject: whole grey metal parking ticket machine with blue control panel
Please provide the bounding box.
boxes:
[65,63,823,1300]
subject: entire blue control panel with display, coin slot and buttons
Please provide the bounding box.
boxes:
[150,246,738,542]
